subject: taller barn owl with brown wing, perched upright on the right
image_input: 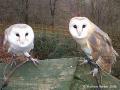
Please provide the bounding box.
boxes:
[69,17,118,76]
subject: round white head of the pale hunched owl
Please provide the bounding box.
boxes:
[5,24,34,47]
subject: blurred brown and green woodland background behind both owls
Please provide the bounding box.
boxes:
[0,0,120,78]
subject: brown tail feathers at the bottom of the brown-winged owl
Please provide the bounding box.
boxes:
[96,57,112,73]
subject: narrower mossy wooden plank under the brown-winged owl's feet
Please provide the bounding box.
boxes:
[71,59,120,90]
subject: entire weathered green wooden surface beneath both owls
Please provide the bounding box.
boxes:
[0,58,120,90]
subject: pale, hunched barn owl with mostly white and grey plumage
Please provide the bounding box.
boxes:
[3,24,38,64]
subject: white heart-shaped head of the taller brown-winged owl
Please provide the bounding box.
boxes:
[69,17,91,39]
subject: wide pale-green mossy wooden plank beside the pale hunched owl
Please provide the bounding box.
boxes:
[0,58,77,90]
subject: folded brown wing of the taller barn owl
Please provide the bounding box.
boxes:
[88,29,118,73]
